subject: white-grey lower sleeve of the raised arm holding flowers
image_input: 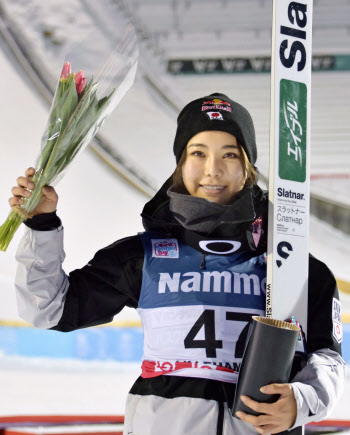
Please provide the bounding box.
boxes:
[15,226,69,329]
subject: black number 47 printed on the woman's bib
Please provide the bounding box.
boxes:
[184,310,254,358]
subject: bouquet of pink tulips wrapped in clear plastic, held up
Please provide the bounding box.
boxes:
[0,25,138,251]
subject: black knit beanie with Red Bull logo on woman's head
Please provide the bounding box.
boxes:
[174,92,257,166]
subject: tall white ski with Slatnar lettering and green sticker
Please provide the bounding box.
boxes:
[266,0,312,334]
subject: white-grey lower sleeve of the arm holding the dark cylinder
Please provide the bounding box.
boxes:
[290,349,346,430]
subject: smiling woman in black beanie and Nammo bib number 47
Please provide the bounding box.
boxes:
[10,93,344,435]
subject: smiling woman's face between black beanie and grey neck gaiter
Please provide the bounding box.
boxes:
[182,131,246,205]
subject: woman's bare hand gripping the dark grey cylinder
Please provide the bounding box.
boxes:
[236,384,297,435]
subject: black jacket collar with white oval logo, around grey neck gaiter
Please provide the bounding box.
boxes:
[141,177,267,255]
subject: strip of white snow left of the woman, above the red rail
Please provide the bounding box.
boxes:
[0,357,140,416]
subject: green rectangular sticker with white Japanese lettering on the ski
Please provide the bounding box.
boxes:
[279,79,307,182]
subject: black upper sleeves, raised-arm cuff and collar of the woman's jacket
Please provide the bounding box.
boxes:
[26,179,341,360]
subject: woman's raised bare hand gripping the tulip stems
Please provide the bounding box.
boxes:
[9,168,58,216]
